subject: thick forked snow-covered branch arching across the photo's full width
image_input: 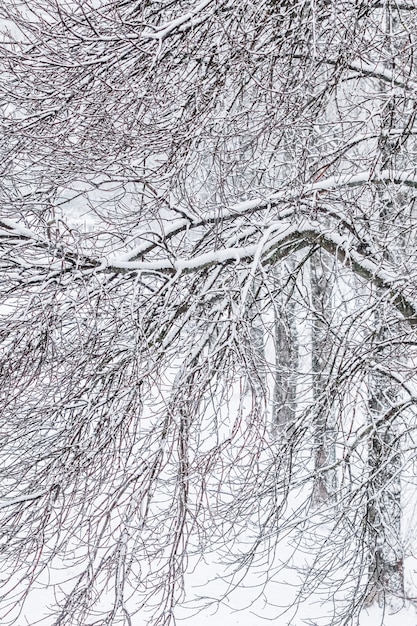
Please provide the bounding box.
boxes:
[0,170,417,325]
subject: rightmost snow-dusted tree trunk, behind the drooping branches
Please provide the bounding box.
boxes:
[366,2,404,611]
